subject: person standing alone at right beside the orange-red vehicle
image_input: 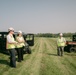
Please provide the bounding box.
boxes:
[57,33,66,56]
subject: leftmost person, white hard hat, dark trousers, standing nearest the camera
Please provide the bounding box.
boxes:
[6,27,17,68]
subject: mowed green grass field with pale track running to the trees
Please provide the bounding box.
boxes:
[0,37,76,75]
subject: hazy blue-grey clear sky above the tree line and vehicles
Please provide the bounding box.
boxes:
[0,0,76,33]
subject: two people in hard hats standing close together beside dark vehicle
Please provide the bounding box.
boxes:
[6,27,25,68]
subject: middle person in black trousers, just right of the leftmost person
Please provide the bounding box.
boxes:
[16,31,25,62]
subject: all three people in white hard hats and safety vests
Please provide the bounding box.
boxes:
[7,28,66,68]
